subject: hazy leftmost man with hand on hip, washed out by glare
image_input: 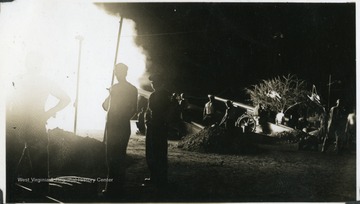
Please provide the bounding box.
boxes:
[6,53,70,199]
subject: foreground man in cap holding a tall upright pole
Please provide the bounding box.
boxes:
[102,63,138,195]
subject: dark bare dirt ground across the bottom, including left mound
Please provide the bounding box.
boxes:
[7,121,356,202]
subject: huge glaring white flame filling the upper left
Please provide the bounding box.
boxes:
[0,0,146,132]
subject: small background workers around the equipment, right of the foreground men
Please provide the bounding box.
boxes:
[203,91,356,153]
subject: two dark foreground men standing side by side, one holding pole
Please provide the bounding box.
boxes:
[103,63,171,196]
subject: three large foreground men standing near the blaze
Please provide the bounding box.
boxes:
[7,56,171,200]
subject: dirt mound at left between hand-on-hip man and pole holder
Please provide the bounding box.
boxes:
[49,128,106,176]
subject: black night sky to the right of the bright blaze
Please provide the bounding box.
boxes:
[99,2,356,108]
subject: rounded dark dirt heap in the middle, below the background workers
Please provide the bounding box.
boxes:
[178,126,259,154]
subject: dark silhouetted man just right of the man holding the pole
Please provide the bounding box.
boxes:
[145,75,171,188]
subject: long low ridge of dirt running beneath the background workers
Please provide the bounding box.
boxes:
[178,126,320,154]
